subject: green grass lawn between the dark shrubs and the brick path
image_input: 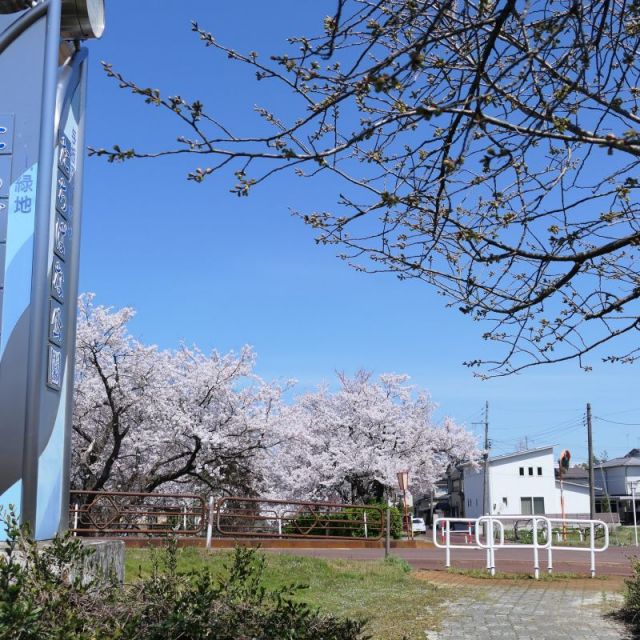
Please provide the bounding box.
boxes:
[125,548,451,640]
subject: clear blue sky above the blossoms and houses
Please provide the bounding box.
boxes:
[80,0,640,460]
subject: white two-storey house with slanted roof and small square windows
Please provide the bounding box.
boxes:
[458,446,589,518]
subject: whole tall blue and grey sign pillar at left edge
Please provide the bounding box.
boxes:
[0,0,104,540]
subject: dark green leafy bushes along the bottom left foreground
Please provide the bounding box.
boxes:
[0,514,369,640]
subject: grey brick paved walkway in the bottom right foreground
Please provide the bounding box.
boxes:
[426,583,631,640]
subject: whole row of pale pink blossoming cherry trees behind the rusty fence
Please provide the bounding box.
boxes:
[72,294,478,502]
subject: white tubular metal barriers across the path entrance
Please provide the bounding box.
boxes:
[433,515,609,580]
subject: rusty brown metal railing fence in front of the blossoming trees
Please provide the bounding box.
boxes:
[69,491,385,546]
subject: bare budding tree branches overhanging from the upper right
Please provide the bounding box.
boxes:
[93,0,640,376]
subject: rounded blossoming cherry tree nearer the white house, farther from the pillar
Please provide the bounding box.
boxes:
[264,372,478,503]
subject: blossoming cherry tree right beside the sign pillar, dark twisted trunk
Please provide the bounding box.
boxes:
[72,294,283,494]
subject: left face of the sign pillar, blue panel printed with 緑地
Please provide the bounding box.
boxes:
[0,16,47,535]
